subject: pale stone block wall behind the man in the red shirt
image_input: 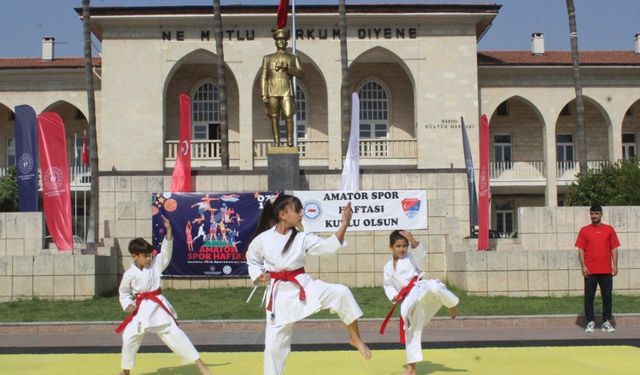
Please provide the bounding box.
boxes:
[447,207,640,297]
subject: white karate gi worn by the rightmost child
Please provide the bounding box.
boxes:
[384,244,459,363]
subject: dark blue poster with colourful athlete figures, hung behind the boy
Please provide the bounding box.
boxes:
[151,192,274,277]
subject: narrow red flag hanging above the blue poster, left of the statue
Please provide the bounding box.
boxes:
[171,94,191,193]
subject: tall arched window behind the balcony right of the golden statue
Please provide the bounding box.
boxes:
[358,81,389,138]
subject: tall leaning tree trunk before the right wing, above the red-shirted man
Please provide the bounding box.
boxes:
[566,0,588,175]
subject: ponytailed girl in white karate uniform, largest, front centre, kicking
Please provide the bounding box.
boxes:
[247,194,371,375]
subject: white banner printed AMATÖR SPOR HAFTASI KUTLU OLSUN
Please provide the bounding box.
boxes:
[293,190,427,232]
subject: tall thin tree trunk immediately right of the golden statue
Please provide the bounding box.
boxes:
[338,0,351,157]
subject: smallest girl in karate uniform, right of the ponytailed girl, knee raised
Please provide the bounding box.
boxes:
[380,230,459,375]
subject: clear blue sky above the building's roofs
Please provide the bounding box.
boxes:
[0,0,640,57]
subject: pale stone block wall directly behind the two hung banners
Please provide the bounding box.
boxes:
[100,171,469,289]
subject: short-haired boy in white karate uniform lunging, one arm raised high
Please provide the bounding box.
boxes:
[116,216,211,375]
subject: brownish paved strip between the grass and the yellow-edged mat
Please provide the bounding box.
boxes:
[0,314,640,354]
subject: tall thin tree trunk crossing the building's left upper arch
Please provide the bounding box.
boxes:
[213,0,229,170]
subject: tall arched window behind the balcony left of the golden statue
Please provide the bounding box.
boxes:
[191,82,220,140]
